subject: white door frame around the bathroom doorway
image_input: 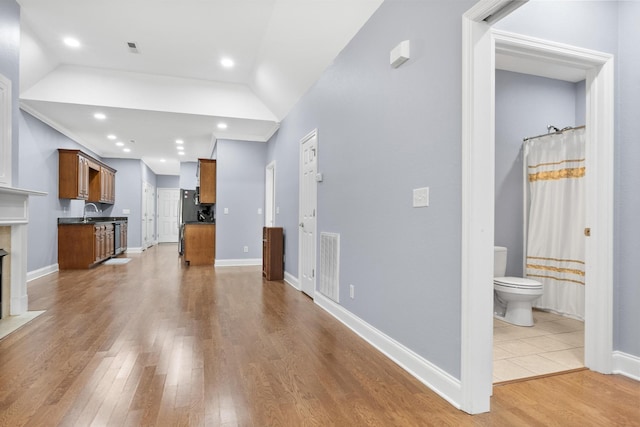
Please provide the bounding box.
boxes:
[460,0,614,414]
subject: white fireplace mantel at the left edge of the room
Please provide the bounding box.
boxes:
[0,186,47,316]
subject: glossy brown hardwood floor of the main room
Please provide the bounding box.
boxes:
[0,245,640,426]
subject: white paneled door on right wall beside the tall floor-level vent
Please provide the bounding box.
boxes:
[299,130,318,298]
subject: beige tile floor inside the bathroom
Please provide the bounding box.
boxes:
[493,310,584,383]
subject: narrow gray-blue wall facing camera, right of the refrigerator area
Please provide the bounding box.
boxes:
[216,139,267,260]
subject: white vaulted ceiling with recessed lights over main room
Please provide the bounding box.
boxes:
[18,0,383,175]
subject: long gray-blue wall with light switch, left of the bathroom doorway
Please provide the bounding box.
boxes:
[267,1,474,377]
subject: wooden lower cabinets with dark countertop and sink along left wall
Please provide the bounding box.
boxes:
[58,223,119,270]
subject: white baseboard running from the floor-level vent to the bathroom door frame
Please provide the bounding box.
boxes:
[314,292,462,409]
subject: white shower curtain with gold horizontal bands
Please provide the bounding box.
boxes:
[525,128,585,320]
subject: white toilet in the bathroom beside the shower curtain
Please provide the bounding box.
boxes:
[493,246,542,326]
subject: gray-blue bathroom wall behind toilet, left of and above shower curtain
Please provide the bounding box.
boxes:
[495,70,585,277]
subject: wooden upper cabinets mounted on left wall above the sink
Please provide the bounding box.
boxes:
[58,149,116,203]
